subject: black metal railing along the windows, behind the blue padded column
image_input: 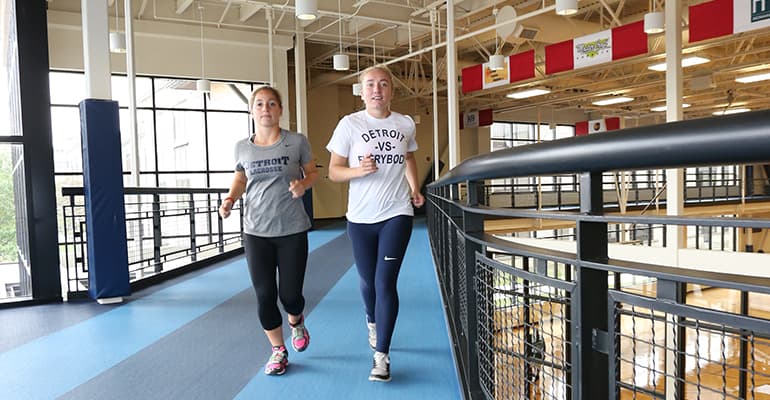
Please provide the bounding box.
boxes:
[60,187,243,297]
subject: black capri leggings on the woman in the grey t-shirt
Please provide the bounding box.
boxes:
[243,232,308,331]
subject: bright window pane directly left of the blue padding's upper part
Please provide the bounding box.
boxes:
[51,107,83,173]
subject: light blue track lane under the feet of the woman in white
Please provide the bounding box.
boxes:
[236,223,462,400]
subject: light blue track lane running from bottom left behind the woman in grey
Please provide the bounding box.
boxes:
[0,228,344,400]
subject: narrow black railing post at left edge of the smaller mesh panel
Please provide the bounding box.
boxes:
[461,181,480,399]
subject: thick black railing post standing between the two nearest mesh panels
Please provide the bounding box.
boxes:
[571,172,614,400]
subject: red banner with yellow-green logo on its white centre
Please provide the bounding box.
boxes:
[545,21,648,74]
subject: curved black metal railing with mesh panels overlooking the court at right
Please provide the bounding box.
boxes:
[427,111,770,400]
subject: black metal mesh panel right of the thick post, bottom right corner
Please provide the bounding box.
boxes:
[611,292,770,400]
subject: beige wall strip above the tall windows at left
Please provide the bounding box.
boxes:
[48,11,294,87]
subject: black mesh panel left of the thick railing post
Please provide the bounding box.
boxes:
[476,256,572,399]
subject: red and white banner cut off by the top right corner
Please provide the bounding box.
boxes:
[689,0,770,43]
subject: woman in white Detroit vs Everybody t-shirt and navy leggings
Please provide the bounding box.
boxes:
[326,65,425,382]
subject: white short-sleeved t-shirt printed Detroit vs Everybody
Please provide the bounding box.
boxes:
[326,110,417,224]
